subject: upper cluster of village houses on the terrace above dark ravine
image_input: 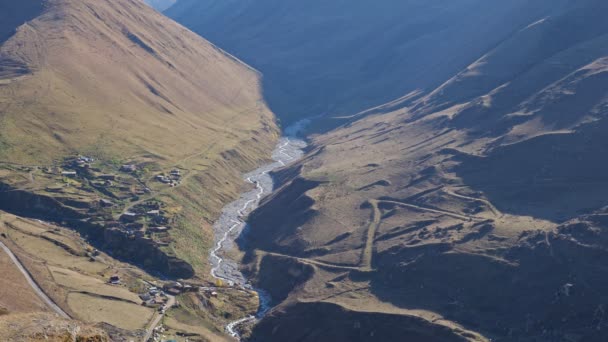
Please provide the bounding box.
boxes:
[0,155,192,274]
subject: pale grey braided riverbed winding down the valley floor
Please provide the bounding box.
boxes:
[210,120,308,340]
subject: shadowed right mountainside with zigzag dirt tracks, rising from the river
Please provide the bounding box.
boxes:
[233,0,608,341]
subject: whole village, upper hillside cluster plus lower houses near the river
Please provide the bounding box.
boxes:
[0,155,258,341]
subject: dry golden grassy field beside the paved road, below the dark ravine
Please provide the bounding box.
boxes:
[0,214,163,330]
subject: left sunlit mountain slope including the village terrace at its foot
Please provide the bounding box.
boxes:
[0,0,277,278]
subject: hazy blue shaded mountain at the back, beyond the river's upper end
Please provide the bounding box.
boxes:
[167,0,567,123]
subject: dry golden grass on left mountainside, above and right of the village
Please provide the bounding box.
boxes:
[0,0,278,286]
